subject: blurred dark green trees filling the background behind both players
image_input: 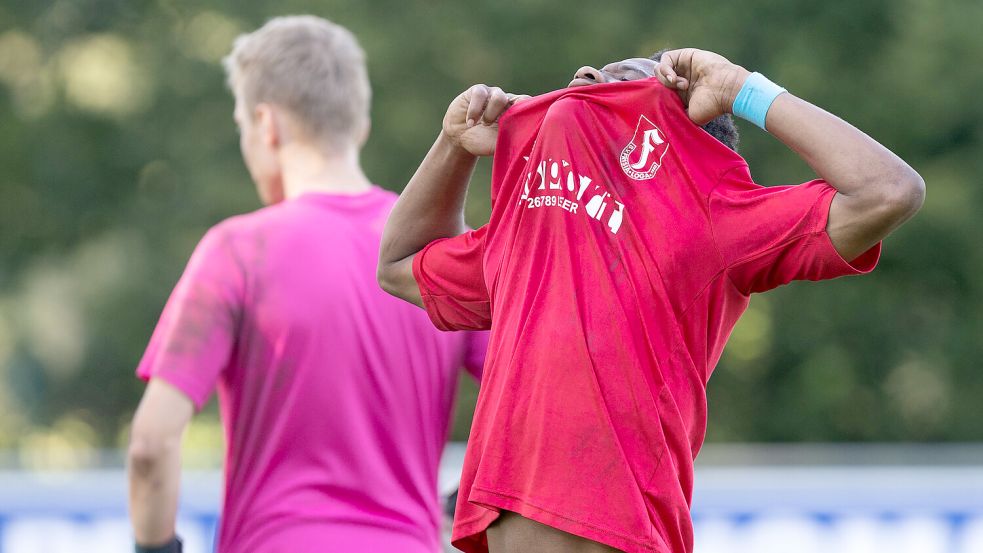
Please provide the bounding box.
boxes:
[0,0,983,467]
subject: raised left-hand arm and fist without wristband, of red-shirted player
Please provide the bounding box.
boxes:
[378,85,521,306]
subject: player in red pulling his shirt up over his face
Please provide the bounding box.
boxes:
[379,48,924,553]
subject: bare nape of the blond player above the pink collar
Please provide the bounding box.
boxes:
[280,140,372,200]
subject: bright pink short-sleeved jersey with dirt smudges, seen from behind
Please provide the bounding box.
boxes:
[137,188,485,553]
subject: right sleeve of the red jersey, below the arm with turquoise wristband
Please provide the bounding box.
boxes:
[708,165,881,294]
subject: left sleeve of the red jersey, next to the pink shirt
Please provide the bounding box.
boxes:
[413,227,491,330]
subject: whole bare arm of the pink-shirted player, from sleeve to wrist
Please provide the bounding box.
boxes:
[127,379,194,547]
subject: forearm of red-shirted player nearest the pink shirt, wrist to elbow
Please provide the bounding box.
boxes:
[379,133,477,264]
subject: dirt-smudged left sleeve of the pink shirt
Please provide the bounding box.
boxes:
[136,224,244,410]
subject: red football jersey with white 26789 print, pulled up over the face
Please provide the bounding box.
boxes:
[413,79,880,553]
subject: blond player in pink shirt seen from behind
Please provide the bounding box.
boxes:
[129,17,486,553]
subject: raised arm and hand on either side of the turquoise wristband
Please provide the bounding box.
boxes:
[656,48,925,261]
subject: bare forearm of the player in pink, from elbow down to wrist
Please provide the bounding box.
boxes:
[128,440,181,546]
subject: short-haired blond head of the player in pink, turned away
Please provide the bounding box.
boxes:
[224,16,371,204]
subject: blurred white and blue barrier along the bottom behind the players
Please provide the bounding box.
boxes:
[0,443,983,553]
